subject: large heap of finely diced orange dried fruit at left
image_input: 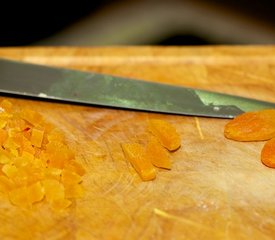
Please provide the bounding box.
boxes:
[0,100,85,210]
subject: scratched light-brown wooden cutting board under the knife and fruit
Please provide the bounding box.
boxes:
[0,46,275,240]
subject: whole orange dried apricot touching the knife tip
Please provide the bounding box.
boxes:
[224,109,275,141]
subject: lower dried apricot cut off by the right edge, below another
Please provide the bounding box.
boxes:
[261,138,275,168]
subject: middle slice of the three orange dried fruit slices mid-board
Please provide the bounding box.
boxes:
[146,137,171,169]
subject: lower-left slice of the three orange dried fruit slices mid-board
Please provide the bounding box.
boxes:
[122,143,156,181]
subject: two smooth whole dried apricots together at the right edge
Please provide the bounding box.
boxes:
[224,109,275,168]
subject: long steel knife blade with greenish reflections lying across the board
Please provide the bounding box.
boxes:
[0,58,275,118]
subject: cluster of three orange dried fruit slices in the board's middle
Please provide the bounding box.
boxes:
[122,119,181,181]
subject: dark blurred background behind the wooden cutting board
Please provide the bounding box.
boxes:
[0,0,275,46]
